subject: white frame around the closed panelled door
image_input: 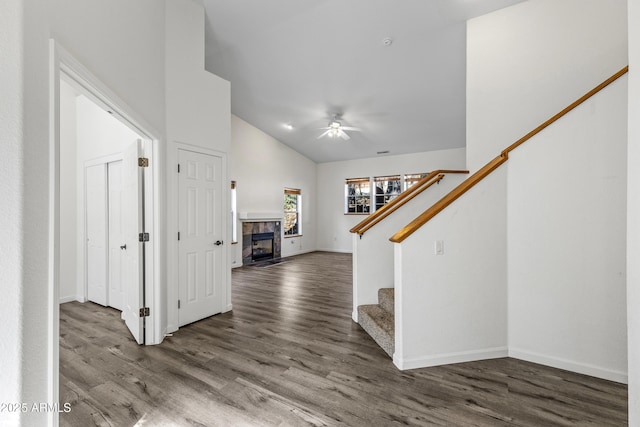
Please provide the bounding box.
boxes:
[166,141,232,333]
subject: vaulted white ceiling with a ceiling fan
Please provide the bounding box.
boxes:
[203,0,522,163]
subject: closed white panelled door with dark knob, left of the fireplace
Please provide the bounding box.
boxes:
[178,150,225,326]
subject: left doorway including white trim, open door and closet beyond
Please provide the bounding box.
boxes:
[52,46,161,348]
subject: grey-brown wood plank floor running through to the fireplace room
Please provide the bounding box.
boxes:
[60,252,627,427]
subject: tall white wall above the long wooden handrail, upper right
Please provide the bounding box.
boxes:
[467,0,627,172]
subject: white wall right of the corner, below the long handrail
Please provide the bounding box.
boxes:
[507,77,627,382]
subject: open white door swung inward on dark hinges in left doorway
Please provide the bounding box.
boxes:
[121,141,144,344]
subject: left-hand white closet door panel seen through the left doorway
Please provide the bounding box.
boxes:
[85,164,109,306]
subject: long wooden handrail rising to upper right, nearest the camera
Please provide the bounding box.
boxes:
[389,65,629,243]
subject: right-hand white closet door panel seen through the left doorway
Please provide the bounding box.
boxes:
[107,161,126,311]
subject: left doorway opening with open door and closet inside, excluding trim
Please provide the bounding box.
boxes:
[60,76,153,344]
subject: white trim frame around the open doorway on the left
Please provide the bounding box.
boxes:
[47,39,163,426]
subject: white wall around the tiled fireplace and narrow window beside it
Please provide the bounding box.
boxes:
[230,116,318,267]
